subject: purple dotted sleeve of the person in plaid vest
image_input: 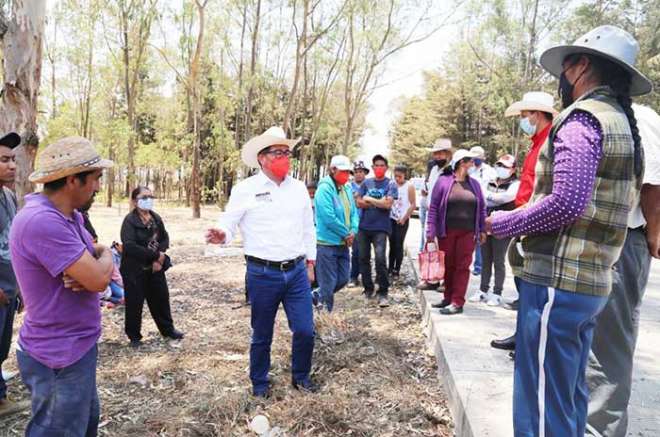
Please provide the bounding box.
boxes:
[493,111,602,237]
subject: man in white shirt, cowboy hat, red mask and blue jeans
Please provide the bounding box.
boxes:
[206,127,318,397]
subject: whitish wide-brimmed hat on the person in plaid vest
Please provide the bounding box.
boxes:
[540,25,653,96]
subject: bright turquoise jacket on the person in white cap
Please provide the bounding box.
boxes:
[314,176,360,246]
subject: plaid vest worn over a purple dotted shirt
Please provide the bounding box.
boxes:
[509,87,641,296]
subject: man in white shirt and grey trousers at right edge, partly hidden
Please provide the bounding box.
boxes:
[587,104,660,437]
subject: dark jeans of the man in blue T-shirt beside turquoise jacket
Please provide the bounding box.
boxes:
[358,230,390,296]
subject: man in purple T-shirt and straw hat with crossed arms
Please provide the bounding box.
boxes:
[9,137,112,437]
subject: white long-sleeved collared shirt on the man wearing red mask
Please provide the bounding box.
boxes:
[219,171,316,261]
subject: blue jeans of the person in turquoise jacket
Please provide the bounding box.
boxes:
[316,245,350,312]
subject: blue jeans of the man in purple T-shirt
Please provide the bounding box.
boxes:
[16,345,100,437]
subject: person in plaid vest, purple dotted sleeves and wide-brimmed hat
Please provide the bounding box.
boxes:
[487,26,651,436]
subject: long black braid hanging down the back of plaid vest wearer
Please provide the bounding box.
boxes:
[588,56,643,177]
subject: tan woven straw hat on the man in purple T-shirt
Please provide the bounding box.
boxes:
[29,137,114,184]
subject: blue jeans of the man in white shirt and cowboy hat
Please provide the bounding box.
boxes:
[247,261,314,393]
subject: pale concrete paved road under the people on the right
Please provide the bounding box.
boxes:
[406,219,660,437]
